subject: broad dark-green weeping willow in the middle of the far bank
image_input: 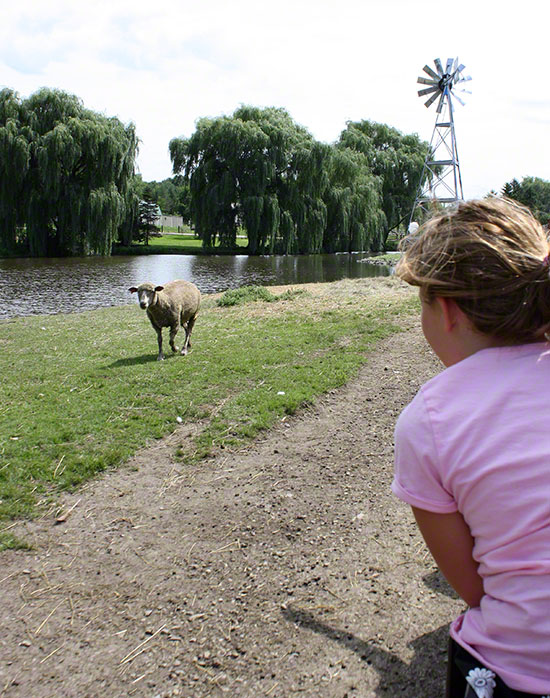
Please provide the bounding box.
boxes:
[170,106,336,254]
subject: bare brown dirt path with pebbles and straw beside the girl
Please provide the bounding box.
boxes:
[0,320,463,698]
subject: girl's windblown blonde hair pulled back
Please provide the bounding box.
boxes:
[395,197,550,344]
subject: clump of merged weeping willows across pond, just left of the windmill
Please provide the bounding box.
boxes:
[169,106,429,254]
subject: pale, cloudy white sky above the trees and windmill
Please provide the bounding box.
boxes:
[0,0,550,198]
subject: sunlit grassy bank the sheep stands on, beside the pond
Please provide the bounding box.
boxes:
[0,278,417,547]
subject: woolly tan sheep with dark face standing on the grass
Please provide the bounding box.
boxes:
[128,279,201,361]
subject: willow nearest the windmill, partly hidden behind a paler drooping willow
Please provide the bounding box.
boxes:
[337,121,429,243]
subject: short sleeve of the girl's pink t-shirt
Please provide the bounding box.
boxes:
[391,390,458,514]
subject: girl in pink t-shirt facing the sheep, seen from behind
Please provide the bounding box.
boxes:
[392,198,550,698]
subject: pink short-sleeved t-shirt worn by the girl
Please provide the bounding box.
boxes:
[392,343,550,694]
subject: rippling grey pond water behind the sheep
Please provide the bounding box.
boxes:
[0,253,391,318]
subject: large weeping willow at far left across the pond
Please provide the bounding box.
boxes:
[0,88,138,256]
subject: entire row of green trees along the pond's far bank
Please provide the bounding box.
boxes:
[0,88,550,256]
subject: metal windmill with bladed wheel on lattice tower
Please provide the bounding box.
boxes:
[409,58,472,230]
